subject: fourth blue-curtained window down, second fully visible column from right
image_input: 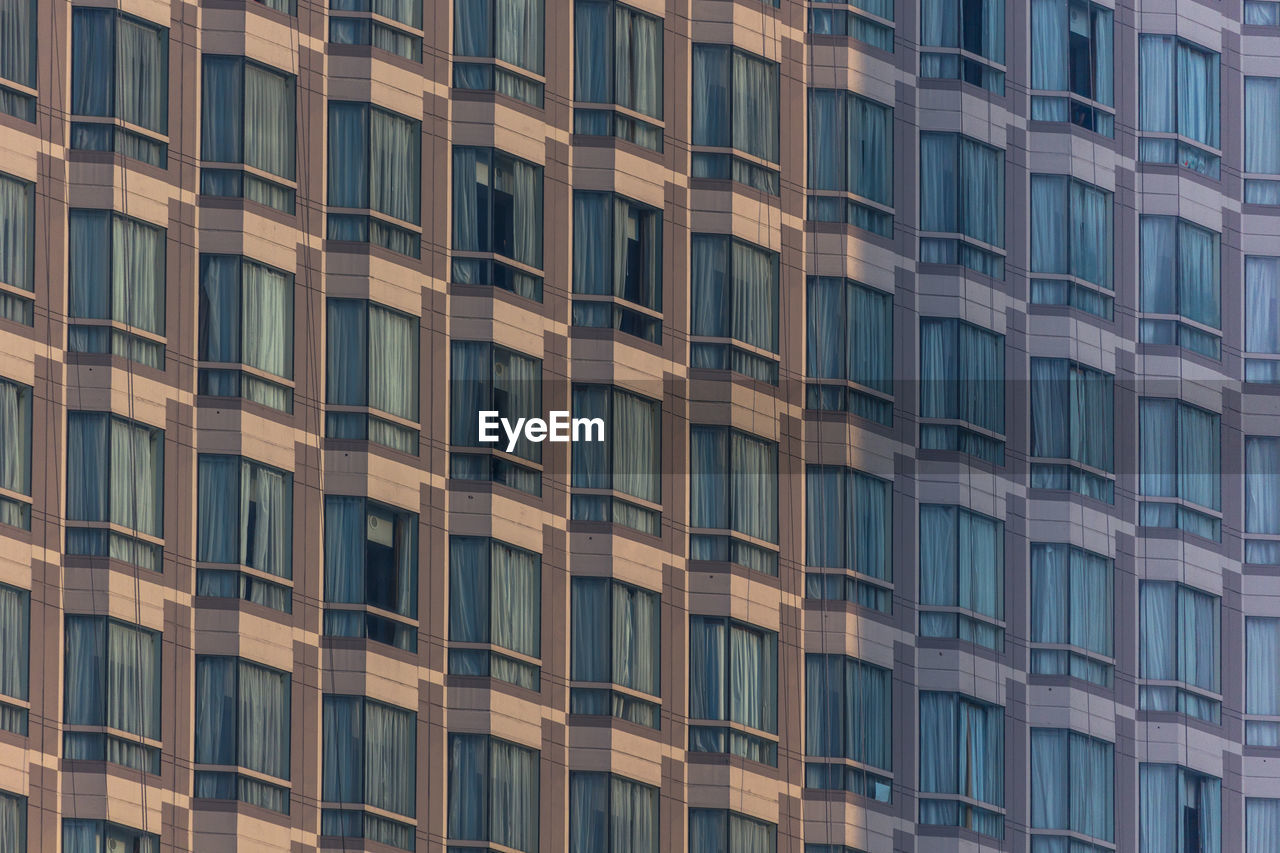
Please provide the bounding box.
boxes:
[1030,542,1115,686]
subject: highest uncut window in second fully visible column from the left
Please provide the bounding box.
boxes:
[200,55,296,214]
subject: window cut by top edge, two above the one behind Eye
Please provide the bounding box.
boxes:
[453,0,543,108]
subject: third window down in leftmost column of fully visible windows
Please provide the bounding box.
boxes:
[67,411,164,571]
